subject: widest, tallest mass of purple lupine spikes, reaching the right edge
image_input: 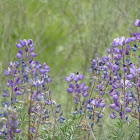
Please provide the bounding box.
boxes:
[65,20,140,139]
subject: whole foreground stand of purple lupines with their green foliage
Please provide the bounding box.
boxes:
[0,20,140,140]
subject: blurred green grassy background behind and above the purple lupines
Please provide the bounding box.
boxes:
[0,0,140,138]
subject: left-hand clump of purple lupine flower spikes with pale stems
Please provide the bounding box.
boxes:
[0,39,65,139]
